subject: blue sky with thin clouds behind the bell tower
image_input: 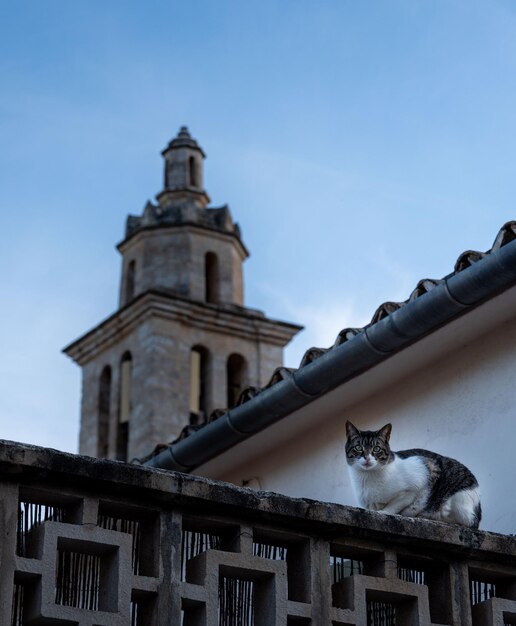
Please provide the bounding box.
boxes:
[0,0,516,451]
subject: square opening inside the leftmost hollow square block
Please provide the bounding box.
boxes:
[55,538,118,612]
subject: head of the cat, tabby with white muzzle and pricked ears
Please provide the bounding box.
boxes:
[346,422,392,471]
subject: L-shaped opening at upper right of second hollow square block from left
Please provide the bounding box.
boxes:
[253,528,311,603]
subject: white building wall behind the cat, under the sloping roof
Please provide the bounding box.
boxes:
[196,294,516,533]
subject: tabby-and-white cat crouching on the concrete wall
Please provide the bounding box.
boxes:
[346,421,482,529]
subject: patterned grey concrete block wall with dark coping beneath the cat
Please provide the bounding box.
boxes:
[0,441,516,626]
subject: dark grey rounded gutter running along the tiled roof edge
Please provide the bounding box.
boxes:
[145,240,516,472]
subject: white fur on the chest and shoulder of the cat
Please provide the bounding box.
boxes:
[349,456,429,511]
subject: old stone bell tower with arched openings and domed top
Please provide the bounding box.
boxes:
[64,126,301,460]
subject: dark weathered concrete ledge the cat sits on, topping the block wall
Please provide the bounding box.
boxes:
[0,440,516,565]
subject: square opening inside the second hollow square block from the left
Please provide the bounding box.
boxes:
[219,576,255,626]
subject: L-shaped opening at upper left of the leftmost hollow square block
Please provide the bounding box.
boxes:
[16,490,80,559]
